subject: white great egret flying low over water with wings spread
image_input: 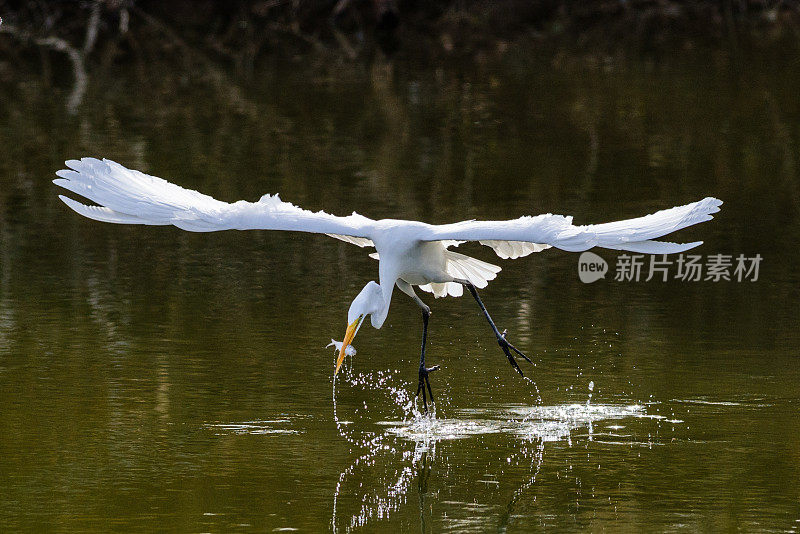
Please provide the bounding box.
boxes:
[53,158,722,410]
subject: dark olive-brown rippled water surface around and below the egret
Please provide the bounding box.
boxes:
[0,45,800,532]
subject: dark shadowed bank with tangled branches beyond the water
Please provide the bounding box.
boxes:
[0,0,800,71]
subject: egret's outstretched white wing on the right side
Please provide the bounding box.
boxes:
[421,197,722,258]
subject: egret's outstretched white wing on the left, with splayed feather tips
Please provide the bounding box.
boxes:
[53,158,375,242]
